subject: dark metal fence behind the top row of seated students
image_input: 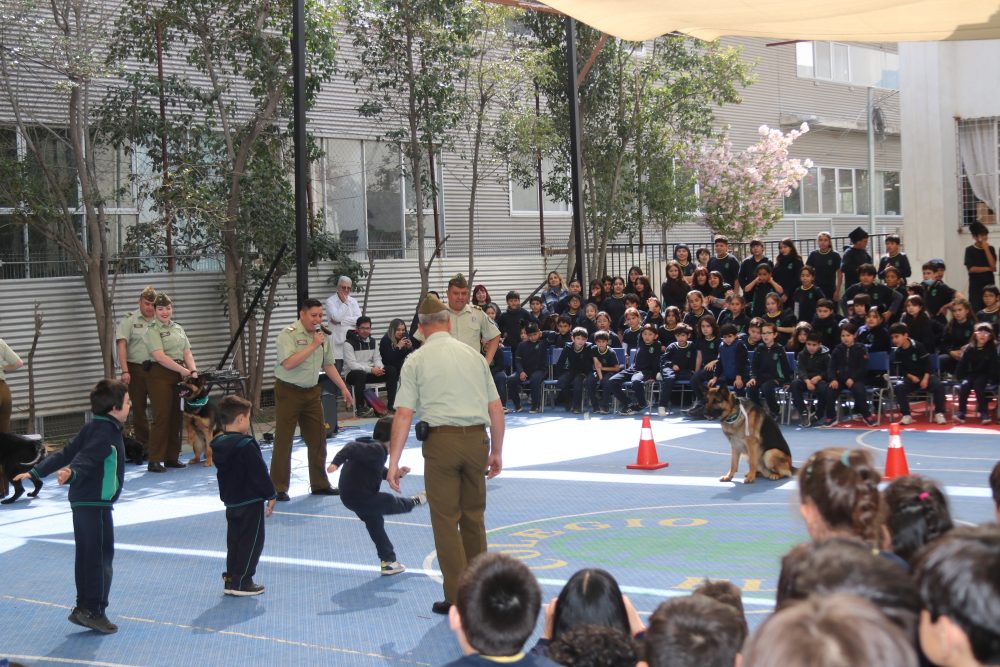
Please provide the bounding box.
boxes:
[605,234,888,280]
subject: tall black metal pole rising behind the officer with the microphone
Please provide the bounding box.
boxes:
[292,0,309,307]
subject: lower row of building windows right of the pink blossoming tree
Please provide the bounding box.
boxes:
[784,167,902,215]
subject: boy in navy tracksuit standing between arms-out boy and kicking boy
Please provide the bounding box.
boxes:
[212,396,277,597]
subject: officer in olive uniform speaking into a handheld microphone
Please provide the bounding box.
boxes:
[271,299,352,500]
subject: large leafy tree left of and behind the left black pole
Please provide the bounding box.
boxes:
[104,0,352,401]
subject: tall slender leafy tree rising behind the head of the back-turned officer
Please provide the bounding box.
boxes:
[344,0,474,293]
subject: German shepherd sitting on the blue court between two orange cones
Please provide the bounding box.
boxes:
[705,385,795,484]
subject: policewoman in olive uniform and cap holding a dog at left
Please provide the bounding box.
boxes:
[146,292,198,472]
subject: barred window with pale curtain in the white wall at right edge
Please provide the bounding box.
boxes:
[957,118,1000,225]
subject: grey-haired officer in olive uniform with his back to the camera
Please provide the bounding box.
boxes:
[386,290,504,614]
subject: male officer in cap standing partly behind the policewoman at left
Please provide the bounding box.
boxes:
[115,287,156,445]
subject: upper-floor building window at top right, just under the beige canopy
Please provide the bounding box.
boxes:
[795,42,899,90]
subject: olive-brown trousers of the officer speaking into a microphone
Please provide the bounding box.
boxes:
[271,380,330,493]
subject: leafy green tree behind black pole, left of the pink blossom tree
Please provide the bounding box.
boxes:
[511,14,751,275]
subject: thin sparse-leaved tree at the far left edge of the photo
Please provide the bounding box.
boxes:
[0,0,123,377]
